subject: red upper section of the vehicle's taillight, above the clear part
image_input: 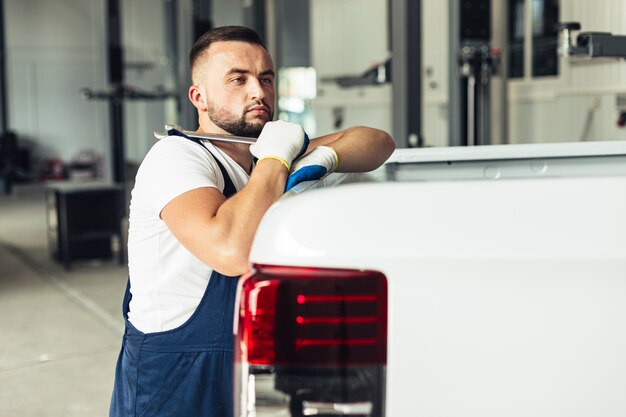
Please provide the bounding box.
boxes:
[238,265,387,366]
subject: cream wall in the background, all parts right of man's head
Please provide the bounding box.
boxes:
[310,0,626,146]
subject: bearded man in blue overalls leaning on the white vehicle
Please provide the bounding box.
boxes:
[110,26,394,417]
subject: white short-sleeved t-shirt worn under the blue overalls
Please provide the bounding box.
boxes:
[128,136,249,333]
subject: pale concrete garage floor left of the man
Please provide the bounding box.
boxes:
[0,186,127,417]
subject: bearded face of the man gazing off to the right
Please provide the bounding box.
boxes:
[197,41,275,137]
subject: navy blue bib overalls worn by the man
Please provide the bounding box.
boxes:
[109,134,238,417]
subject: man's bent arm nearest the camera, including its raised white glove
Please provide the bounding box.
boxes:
[160,121,308,276]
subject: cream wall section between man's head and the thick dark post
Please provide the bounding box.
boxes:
[310,0,392,135]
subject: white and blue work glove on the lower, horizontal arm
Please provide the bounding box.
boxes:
[285,146,339,192]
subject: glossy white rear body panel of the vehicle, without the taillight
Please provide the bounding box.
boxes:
[250,141,626,416]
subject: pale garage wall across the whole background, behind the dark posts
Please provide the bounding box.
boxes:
[4,0,626,172]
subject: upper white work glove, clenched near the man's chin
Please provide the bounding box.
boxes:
[250,120,309,170]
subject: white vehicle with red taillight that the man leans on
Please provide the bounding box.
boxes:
[235,142,626,417]
